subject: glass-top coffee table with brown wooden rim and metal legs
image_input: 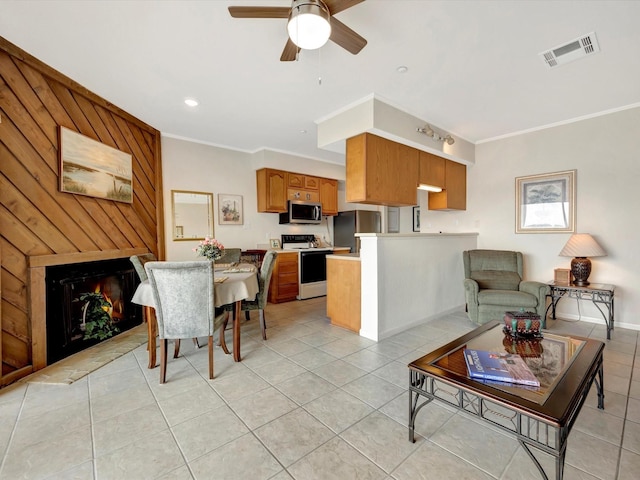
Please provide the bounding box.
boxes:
[409,322,604,480]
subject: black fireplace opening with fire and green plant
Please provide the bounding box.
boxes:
[46,258,142,365]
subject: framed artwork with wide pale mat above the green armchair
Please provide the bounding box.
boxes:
[516,170,576,233]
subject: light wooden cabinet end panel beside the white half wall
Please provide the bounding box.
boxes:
[327,255,361,333]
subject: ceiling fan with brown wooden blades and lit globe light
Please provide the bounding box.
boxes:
[229,0,367,62]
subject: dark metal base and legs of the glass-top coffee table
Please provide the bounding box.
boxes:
[409,355,604,480]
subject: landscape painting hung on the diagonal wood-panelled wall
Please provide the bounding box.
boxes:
[58,126,133,203]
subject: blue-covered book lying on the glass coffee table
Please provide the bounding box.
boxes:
[464,348,540,387]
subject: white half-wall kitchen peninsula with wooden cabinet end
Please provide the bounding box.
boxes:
[327,233,478,341]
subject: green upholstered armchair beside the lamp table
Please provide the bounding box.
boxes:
[462,250,550,328]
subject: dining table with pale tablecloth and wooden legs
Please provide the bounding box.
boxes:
[131,264,259,368]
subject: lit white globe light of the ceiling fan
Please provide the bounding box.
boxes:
[287,0,331,50]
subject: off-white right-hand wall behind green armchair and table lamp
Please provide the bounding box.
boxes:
[420,108,640,329]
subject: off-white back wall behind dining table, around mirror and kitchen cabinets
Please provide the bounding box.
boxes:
[162,136,362,260]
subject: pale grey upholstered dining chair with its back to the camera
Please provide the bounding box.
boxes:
[144,261,229,384]
